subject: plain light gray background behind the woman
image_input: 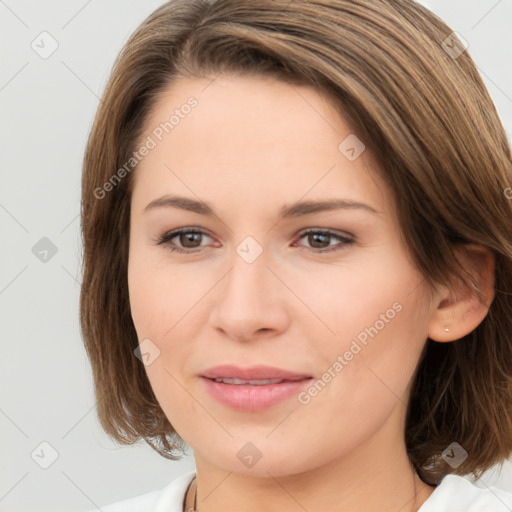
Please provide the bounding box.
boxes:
[0,0,512,512]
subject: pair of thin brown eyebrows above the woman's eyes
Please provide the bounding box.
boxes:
[143,196,381,219]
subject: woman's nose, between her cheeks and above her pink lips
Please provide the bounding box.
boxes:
[210,241,290,341]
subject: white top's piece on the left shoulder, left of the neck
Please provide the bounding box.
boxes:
[88,471,195,512]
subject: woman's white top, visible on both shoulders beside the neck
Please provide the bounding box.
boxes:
[89,471,512,512]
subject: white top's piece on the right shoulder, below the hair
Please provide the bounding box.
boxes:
[418,474,512,512]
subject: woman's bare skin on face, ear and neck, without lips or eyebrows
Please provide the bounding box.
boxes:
[128,76,493,512]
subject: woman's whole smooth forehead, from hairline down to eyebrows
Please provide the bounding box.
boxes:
[133,75,388,216]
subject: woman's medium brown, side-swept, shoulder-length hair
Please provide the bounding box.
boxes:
[80,0,512,484]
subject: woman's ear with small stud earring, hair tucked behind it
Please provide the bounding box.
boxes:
[428,244,494,342]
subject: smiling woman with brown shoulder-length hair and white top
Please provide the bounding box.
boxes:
[81,0,512,512]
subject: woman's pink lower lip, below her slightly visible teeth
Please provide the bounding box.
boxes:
[202,377,311,412]
